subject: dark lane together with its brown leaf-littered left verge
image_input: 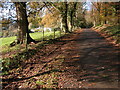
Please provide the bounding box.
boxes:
[3,29,120,90]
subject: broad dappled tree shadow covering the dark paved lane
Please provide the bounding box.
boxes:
[59,31,120,86]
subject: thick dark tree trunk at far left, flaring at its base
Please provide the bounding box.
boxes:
[14,2,35,43]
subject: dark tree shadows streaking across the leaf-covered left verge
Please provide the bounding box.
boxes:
[2,32,75,87]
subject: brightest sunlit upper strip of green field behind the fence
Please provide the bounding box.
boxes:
[0,31,60,46]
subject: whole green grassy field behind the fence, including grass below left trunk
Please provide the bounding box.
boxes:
[0,31,64,53]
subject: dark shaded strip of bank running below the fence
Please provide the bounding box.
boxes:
[2,34,73,72]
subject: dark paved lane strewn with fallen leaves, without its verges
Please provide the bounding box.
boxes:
[59,29,120,88]
